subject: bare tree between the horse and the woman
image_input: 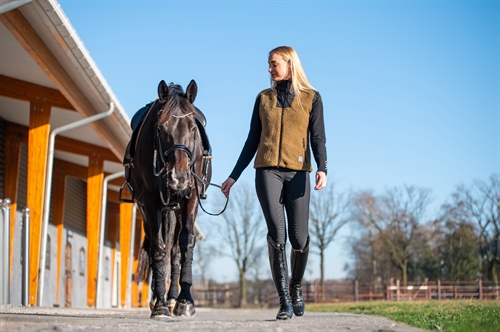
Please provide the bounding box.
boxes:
[211,183,265,307]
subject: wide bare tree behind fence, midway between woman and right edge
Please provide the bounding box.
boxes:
[354,186,430,285]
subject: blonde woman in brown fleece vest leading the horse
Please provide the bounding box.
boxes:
[222,46,327,319]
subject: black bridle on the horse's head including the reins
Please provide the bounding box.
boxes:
[153,107,229,216]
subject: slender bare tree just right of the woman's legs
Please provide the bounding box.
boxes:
[309,181,349,298]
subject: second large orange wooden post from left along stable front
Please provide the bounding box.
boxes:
[87,158,104,307]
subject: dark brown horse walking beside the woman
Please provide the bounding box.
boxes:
[126,80,212,319]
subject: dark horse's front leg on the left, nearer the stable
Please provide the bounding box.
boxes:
[144,204,172,318]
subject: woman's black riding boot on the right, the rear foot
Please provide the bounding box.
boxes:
[290,237,309,316]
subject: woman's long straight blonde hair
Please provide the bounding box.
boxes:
[269,46,316,103]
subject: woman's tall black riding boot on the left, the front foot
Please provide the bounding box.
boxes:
[267,236,292,320]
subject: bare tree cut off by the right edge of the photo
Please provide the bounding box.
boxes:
[450,174,500,282]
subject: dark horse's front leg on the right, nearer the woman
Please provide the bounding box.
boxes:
[174,195,198,317]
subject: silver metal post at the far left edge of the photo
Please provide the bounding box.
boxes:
[0,198,10,304]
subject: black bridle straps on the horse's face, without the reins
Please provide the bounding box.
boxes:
[153,113,197,210]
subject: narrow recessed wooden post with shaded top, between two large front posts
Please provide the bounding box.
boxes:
[51,173,66,304]
